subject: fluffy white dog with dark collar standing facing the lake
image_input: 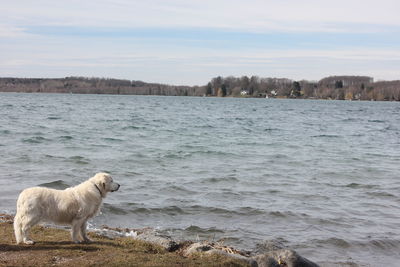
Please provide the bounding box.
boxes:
[14,173,120,244]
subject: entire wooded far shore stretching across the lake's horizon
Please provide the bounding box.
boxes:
[0,76,400,101]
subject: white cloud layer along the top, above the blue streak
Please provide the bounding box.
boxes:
[2,0,400,32]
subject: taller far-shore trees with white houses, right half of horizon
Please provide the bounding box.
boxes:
[206,76,400,101]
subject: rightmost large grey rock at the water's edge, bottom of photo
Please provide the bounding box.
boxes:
[253,249,319,267]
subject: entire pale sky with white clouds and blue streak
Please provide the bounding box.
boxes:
[0,0,400,85]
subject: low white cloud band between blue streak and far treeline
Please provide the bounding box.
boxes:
[0,40,400,85]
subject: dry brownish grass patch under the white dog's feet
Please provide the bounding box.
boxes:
[0,221,248,267]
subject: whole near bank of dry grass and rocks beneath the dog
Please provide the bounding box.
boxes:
[0,214,318,267]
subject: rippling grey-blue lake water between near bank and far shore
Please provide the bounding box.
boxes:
[0,93,400,266]
